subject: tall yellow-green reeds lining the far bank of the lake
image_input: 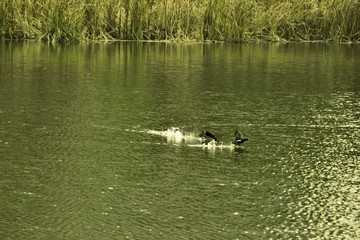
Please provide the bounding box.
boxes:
[0,0,360,42]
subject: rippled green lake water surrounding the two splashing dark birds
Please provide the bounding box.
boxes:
[0,42,360,240]
